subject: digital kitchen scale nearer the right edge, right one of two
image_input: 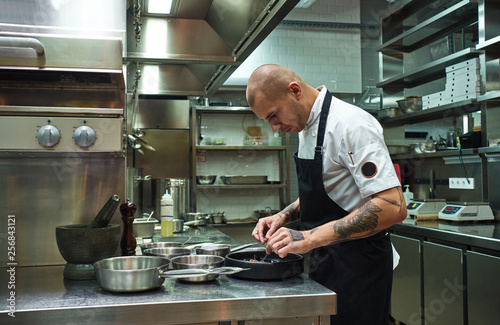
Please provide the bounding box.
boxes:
[438,202,495,221]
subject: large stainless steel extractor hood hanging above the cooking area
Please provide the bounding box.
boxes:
[124,0,298,96]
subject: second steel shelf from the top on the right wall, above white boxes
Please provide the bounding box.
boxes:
[377,47,481,89]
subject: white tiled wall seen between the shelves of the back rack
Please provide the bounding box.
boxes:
[196,113,281,221]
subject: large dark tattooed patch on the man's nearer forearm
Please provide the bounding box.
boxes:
[333,201,382,241]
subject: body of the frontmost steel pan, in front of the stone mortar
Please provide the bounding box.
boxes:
[93,256,169,292]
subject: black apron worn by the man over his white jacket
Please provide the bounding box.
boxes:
[294,91,393,325]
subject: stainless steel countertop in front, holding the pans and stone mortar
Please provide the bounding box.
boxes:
[0,227,336,324]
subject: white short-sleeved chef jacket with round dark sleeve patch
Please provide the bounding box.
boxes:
[298,86,401,213]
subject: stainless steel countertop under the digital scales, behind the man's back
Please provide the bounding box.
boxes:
[390,219,500,252]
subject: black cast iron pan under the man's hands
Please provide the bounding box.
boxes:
[226,249,304,280]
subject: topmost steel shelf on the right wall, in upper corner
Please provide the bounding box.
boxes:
[377,0,478,55]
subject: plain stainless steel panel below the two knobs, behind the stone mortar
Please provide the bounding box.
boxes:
[0,152,125,266]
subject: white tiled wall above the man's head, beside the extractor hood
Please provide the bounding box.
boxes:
[225,0,361,93]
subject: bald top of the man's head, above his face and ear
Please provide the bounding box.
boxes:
[247,64,307,107]
